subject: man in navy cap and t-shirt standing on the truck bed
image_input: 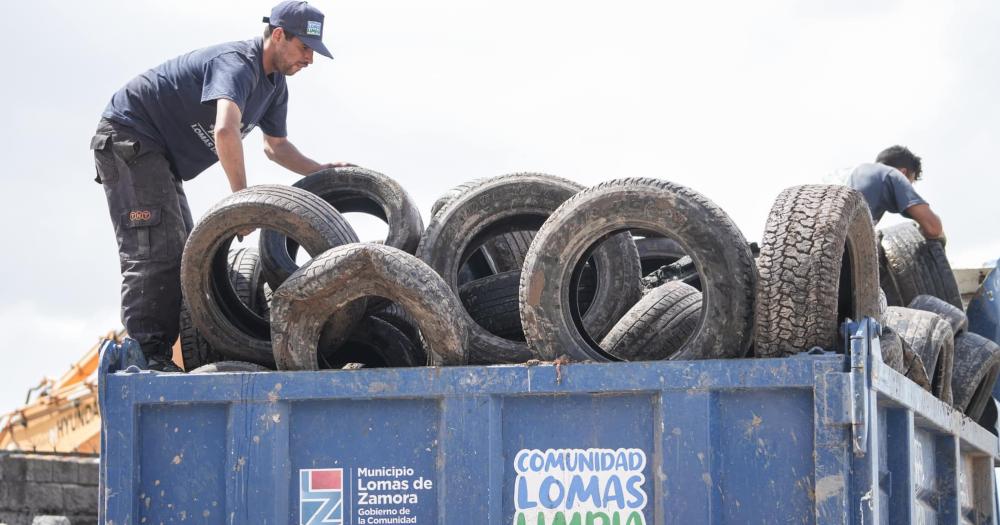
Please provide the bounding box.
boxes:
[90,1,342,371]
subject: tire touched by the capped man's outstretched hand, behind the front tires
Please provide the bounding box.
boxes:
[260,167,424,289]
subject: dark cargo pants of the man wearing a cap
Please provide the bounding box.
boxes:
[90,119,194,359]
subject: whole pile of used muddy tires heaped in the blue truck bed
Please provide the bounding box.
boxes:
[181,172,1000,417]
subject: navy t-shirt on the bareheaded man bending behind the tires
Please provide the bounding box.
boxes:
[846,163,927,222]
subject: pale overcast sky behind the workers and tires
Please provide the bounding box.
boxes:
[0,0,1000,412]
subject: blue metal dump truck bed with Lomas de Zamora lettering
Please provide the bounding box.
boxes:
[100,320,1000,525]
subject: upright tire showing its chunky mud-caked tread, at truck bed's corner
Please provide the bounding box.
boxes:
[755,185,879,357]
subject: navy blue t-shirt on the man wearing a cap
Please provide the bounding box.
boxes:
[103,37,288,180]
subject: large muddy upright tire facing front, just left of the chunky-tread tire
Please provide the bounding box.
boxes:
[520,179,757,361]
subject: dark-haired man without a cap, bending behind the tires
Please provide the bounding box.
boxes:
[847,146,944,239]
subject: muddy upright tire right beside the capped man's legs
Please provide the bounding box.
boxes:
[181,185,364,366]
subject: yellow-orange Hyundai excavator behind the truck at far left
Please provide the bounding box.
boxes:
[0,330,180,454]
